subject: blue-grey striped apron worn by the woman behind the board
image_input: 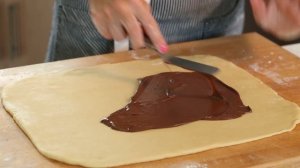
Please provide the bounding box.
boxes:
[46,0,244,61]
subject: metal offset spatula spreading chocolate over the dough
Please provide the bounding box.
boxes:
[145,38,219,74]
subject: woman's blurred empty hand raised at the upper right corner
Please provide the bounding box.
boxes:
[250,0,300,40]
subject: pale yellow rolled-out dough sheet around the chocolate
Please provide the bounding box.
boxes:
[2,56,300,167]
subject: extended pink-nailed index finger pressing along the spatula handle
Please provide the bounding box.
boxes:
[136,4,168,53]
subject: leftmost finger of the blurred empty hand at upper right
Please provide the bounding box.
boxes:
[250,0,268,26]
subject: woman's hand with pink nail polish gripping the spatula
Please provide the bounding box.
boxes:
[89,0,168,52]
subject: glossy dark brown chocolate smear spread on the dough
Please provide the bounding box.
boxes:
[101,72,251,132]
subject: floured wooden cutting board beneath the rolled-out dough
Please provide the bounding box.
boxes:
[0,33,300,168]
